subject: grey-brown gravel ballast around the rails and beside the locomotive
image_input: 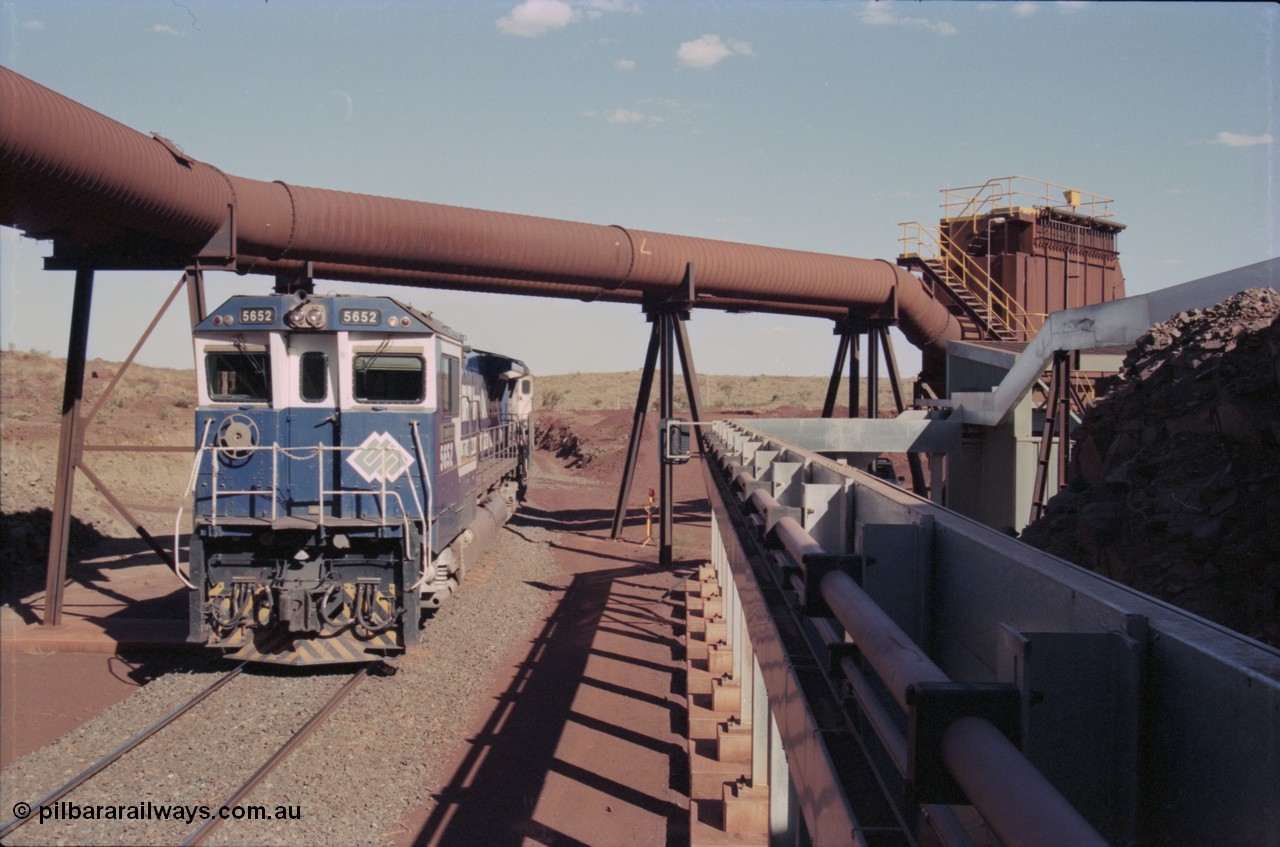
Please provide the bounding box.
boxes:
[0,516,561,844]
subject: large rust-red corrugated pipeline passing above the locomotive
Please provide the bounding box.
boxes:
[0,68,960,351]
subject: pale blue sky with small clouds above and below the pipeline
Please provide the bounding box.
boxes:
[0,0,1280,375]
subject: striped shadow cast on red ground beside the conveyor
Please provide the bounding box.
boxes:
[415,562,689,847]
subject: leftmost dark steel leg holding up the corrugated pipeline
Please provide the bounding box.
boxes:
[44,267,93,627]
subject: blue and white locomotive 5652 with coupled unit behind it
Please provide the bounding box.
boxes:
[179,293,532,664]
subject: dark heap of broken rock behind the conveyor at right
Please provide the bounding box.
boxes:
[1023,289,1280,646]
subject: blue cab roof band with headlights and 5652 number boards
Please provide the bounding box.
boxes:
[204,293,466,342]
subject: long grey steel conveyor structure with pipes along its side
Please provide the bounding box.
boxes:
[690,421,1280,847]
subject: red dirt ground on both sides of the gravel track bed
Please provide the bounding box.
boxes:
[0,411,709,844]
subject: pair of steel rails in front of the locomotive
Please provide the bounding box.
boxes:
[0,661,384,844]
